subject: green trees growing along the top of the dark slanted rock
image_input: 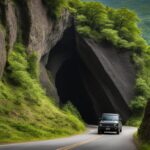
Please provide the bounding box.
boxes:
[69,0,146,53]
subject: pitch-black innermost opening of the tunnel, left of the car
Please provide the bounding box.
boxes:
[55,58,97,123]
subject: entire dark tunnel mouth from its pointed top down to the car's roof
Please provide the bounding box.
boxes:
[44,27,126,124]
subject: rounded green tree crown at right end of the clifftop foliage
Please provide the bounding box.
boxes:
[108,8,140,42]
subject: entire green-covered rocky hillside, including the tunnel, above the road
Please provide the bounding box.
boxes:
[0,0,150,143]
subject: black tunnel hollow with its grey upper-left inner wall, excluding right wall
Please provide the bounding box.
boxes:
[42,27,97,123]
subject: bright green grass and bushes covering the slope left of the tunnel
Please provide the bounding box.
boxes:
[0,44,84,143]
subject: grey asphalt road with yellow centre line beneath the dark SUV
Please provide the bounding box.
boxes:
[0,127,136,150]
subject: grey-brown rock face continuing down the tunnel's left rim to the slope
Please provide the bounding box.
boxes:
[27,0,71,103]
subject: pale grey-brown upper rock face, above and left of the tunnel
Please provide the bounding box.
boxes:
[28,0,70,58]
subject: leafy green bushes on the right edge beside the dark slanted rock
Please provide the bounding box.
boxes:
[131,51,150,113]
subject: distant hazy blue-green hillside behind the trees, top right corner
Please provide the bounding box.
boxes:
[97,0,150,43]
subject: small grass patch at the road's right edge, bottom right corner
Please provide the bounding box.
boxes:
[134,133,150,150]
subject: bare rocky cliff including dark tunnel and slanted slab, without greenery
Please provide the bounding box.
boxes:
[0,0,135,123]
